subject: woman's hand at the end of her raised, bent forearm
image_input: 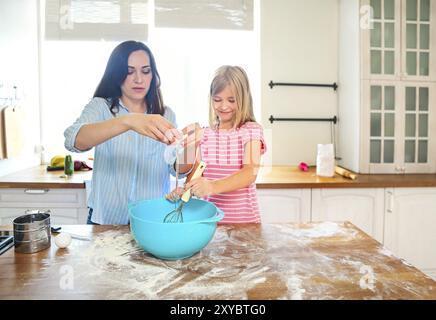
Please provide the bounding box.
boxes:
[124,113,183,144]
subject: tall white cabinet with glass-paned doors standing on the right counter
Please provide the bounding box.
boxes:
[338,0,436,174]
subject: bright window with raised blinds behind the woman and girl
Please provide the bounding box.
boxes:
[41,0,260,161]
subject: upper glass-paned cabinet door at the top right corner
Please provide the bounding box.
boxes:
[401,0,436,81]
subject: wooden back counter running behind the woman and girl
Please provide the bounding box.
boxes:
[0,166,436,189]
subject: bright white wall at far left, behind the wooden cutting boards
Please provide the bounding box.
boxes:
[0,0,40,176]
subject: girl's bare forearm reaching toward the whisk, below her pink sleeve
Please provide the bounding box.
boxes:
[212,165,259,194]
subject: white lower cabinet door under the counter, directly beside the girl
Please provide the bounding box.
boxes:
[257,189,310,223]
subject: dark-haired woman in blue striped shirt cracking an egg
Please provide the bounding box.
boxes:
[64,41,191,224]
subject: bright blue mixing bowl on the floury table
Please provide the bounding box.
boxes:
[128,198,224,260]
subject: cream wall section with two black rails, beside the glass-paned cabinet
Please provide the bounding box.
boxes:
[261,0,340,164]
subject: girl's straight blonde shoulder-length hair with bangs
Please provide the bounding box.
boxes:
[209,66,256,128]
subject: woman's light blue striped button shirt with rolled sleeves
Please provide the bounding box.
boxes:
[64,98,182,224]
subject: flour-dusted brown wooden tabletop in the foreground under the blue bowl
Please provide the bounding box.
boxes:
[0,222,436,300]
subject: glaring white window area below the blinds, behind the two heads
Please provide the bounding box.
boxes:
[38,0,260,162]
